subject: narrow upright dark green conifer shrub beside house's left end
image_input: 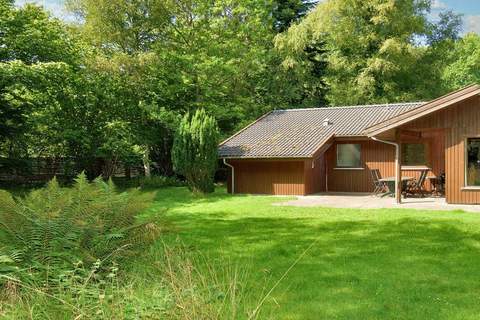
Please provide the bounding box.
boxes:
[172,109,219,193]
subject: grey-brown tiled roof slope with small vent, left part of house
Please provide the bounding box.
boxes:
[218,102,424,158]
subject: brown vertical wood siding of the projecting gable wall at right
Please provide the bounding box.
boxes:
[400,96,480,204]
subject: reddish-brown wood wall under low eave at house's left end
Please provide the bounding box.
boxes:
[229,159,306,195]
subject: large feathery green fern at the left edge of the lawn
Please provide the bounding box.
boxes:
[0,174,159,281]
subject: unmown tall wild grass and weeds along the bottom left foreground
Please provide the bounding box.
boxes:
[0,246,256,320]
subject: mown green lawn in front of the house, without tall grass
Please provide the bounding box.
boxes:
[133,188,480,319]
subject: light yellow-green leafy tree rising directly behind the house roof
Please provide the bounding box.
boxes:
[276,0,464,105]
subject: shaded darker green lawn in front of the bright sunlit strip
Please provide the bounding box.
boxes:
[163,212,480,319]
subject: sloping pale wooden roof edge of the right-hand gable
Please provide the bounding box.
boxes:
[363,84,480,137]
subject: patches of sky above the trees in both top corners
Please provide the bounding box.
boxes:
[15,0,480,34]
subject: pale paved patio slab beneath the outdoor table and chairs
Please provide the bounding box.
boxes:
[275,192,480,212]
